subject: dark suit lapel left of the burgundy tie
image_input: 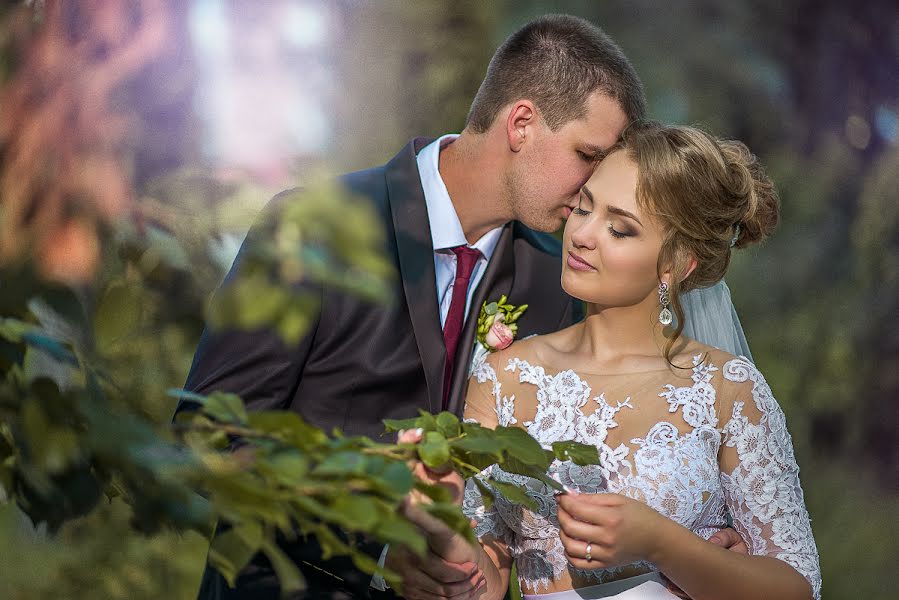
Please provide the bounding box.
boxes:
[386,138,446,412]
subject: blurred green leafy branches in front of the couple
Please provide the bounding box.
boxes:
[0,179,598,590]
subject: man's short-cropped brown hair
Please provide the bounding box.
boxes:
[465,15,646,133]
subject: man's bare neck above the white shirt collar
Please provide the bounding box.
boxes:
[438,130,512,244]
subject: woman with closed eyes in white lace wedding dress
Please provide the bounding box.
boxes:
[450,123,821,600]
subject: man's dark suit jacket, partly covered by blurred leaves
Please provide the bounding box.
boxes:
[185,139,581,600]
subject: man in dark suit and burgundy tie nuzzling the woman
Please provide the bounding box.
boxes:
[179,16,738,600]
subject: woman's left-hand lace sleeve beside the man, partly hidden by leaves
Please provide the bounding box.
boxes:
[462,356,515,546]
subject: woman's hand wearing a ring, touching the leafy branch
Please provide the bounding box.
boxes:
[556,494,672,570]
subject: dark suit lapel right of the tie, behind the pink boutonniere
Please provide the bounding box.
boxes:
[444,223,515,415]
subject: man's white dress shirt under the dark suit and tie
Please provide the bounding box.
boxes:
[371,133,503,591]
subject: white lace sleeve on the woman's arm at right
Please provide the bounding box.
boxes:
[719,358,821,600]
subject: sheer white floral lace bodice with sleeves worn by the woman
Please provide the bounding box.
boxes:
[464,344,821,598]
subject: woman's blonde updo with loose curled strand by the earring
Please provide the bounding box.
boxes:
[610,121,780,362]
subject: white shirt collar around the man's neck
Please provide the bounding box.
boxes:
[416,133,502,260]
